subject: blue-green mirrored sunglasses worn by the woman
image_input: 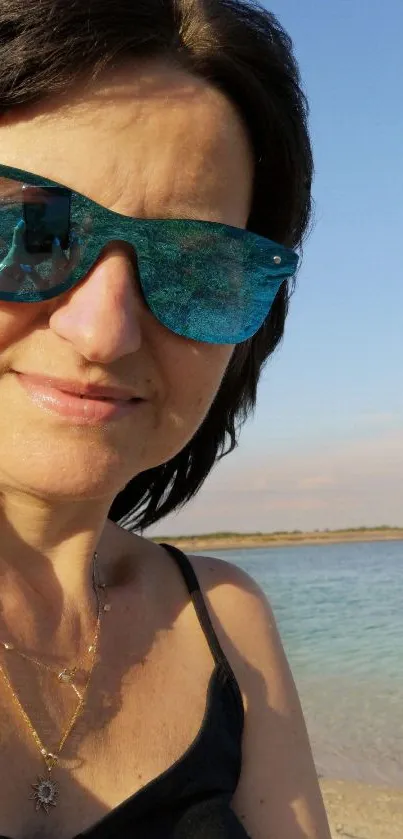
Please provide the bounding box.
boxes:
[0,165,298,344]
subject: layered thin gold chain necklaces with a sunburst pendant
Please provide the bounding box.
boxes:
[0,553,111,813]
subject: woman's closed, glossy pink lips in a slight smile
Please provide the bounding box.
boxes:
[16,373,144,425]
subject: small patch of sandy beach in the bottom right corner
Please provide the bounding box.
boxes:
[320,778,403,839]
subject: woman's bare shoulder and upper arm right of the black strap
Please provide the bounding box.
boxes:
[189,556,330,839]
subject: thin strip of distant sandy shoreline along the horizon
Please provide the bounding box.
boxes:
[153,528,403,551]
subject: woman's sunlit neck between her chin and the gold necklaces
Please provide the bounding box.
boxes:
[0,496,120,659]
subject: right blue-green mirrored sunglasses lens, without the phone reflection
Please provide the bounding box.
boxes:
[138,221,295,344]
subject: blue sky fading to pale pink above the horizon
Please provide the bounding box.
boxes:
[148,0,403,535]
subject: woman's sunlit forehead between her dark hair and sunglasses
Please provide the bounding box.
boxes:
[0,59,253,224]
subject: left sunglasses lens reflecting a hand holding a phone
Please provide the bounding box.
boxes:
[0,178,90,302]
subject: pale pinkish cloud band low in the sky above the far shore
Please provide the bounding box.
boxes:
[149,429,403,533]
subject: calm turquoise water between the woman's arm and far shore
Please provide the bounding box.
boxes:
[198,542,403,787]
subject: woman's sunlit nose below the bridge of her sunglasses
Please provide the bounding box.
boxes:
[49,245,145,364]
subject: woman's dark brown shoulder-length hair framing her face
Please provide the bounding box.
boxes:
[0,0,313,530]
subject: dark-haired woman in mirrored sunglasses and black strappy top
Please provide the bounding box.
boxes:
[0,0,329,839]
